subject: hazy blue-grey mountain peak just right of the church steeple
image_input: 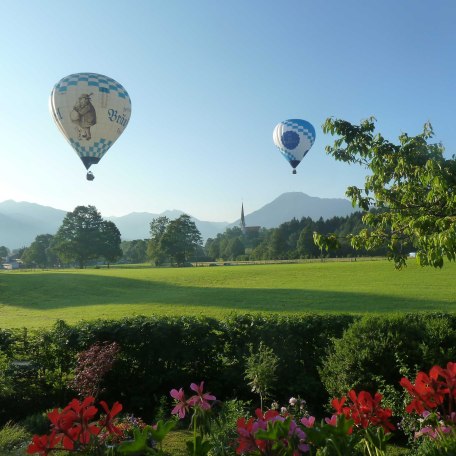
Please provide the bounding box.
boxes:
[230,192,358,228]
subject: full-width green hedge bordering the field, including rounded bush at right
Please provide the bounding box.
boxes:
[0,314,456,422]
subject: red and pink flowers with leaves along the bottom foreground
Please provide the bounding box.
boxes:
[27,362,456,456]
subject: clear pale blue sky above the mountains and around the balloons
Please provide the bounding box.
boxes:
[0,0,456,222]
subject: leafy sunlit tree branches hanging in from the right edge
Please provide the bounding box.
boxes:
[315,118,456,268]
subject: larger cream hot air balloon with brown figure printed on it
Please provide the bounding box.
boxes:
[49,73,131,180]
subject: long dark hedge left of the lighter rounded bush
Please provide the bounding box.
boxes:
[0,315,355,422]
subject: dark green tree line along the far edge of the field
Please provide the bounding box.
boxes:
[10,206,386,268]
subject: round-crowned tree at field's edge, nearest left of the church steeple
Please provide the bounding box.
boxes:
[160,214,203,266]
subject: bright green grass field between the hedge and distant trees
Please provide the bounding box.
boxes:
[0,261,456,328]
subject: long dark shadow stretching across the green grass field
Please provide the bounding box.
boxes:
[0,272,456,313]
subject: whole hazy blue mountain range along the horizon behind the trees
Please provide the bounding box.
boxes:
[0,192,356,250]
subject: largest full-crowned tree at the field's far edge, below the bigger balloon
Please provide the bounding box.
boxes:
[52,206,120,268]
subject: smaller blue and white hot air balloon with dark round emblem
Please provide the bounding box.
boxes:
[272,119,315,174]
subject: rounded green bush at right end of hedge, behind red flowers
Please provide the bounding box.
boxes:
[320,314,456,396]
